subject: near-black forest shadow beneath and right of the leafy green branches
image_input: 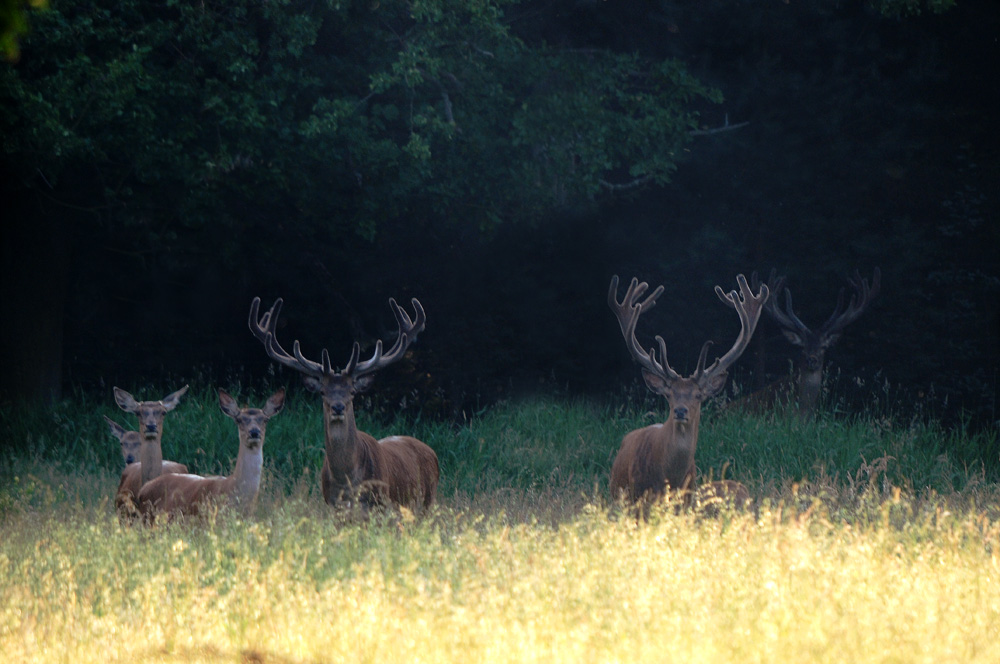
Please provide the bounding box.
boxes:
[3,0,1000,425]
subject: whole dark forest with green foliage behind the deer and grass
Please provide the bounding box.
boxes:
[0,0,1000,427]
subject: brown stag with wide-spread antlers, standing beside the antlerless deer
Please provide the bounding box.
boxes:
[249,298,440,514]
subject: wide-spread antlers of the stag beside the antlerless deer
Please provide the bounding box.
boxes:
[249,297,427,378]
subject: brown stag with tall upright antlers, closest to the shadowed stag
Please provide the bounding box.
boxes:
[608,274,768,505]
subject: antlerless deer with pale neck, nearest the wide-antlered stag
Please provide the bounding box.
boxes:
[137,388,285,523]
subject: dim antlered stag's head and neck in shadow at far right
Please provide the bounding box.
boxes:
[751,267,882,418]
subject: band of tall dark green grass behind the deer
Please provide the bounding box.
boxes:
[0,386,1000,508]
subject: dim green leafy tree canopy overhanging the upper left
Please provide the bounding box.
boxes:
[0,0,718,237]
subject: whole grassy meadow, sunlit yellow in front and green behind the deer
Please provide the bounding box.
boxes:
[0,385,1000,663]
